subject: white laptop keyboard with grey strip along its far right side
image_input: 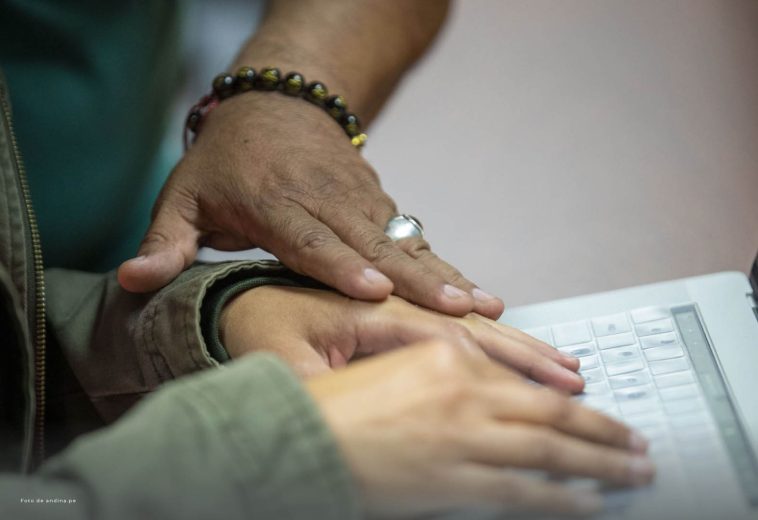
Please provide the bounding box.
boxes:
[525,304,758,513]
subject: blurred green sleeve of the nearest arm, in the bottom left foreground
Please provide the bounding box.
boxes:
[0,354,360,520]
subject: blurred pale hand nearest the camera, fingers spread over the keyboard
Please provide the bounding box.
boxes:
[306,341,655,516]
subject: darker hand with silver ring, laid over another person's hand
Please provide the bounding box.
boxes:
[118,92,503,318]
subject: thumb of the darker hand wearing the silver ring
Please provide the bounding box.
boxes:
[118,205,200,293]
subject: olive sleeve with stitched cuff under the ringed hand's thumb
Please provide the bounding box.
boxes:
[46,261,312,426]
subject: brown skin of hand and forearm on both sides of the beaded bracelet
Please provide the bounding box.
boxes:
[118,0,503,318]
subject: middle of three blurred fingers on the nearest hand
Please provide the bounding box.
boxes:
[466,422,655,486]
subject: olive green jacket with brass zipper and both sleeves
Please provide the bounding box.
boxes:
[0,72,359,520]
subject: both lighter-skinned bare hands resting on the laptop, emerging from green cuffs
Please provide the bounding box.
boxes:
[220,286,655,517]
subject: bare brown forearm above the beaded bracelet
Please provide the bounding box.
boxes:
[232,0,448,121]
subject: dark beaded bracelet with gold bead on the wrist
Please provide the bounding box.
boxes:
[184,67,368,150]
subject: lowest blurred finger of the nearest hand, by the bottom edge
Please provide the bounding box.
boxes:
[446,464,603,515]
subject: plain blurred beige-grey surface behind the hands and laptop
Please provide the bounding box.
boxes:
[197,0,758,306]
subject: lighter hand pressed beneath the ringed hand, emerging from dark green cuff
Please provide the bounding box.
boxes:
[220,286,584,392]
